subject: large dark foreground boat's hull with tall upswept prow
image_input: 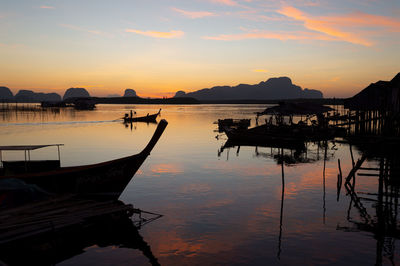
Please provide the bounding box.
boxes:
[0,120,168,198]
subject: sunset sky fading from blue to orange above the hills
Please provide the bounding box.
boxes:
[0,0,400,97]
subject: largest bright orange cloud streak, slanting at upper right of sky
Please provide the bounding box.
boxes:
[278,6,400,46]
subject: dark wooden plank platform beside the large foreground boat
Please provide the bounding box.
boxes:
[0,197,134,243]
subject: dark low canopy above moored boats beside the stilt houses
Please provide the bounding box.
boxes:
[257,102,333,116]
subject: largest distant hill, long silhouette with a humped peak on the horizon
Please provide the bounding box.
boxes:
[174,77,323,101]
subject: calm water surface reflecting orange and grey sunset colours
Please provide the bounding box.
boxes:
[0,105,399,265]
